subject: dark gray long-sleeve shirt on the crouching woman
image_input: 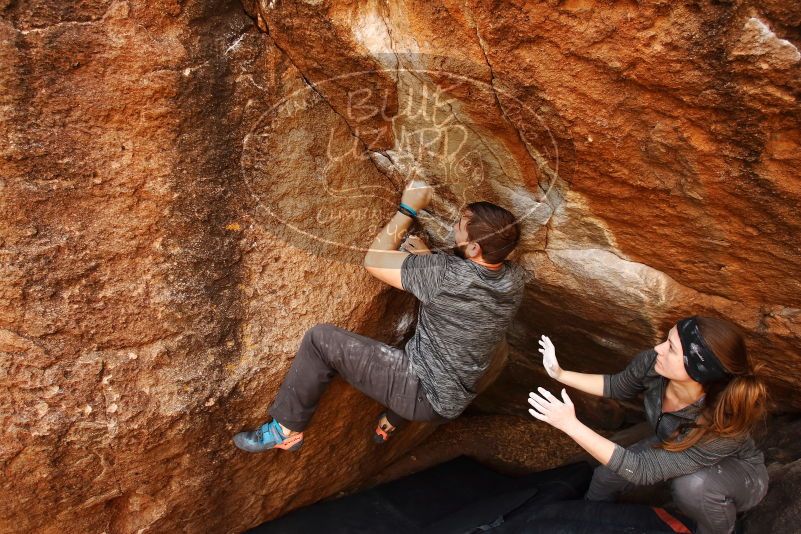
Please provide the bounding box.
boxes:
[604,349,765,484]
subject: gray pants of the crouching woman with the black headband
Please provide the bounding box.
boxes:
[585,437,768,534]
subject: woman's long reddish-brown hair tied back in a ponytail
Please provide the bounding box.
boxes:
[662,317,767,452]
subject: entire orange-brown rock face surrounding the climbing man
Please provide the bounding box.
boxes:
[0,0,801,532]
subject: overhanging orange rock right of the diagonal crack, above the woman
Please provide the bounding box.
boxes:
[246,2,801,407]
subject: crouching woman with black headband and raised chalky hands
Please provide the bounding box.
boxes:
[529,317,768,534]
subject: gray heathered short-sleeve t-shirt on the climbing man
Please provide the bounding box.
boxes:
[401,254,524,419]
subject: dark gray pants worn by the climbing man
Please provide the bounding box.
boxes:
[270,324,446,432]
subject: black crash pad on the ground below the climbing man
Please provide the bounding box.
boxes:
[249,457,687,534]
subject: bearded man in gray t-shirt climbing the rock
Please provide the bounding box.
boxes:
[234,181,523,452]
